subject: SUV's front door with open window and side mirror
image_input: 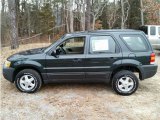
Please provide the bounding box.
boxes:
[45,37,85,82]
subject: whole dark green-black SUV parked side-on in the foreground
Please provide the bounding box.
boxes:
[3,30,157,95]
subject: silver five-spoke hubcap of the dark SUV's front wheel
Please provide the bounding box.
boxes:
[20,75,35,90]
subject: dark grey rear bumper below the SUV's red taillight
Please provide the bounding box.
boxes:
[141,65,158,80]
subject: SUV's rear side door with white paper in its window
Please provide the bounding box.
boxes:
[85,35,122,82]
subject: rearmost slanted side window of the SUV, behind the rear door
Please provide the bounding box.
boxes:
[122,35,148,51]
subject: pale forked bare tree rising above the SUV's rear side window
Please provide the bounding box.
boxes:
[121,0,130,29]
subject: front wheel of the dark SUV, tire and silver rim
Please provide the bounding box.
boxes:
[15,69,42,93]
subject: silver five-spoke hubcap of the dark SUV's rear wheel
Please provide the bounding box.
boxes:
[118,76,134,92]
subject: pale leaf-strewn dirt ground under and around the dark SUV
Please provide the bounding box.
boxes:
[0,45,160,120]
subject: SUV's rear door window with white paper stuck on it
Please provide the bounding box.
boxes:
[90,36,116,53]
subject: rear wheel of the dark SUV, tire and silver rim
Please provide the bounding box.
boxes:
[112,70,139,96]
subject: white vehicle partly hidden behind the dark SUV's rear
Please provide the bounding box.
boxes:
[139,25,160,50]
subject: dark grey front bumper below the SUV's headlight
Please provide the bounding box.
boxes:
[3,66,15,82]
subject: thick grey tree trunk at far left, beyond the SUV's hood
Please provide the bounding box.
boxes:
[8,0,19,49]
